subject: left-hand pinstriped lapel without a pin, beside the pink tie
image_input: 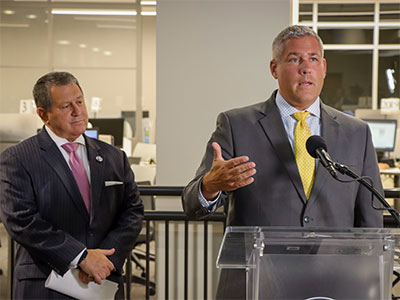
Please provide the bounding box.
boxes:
[38,129,89,220]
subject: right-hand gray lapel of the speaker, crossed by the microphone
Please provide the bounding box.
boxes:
[308,102,340,205]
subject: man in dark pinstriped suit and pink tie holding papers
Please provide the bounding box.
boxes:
[0,72,143,299]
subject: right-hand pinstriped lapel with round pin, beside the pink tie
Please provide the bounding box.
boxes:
[85,136,105,221]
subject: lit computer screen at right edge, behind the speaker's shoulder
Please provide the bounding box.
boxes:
[364,119,397,152]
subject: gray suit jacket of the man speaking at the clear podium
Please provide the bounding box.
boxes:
[182,91,383,299]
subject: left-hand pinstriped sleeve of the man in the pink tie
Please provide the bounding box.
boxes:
[0,149,85,275]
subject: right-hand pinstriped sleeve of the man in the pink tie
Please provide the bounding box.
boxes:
[99,154,144,273]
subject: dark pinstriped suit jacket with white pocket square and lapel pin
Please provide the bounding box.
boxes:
[0,130,143,299]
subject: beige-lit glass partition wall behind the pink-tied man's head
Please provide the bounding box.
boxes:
[0,0,156,147]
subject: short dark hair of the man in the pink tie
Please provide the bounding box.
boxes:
[33,72,83,111]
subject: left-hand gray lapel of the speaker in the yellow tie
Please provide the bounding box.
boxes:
[259,92,306,203]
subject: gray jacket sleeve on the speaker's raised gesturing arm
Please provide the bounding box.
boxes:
[182,113,234,219]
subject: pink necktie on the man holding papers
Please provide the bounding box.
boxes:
[61,143,90,212]
